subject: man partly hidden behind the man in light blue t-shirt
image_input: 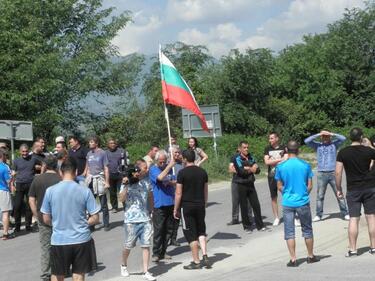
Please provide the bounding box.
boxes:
[29,155,61,280]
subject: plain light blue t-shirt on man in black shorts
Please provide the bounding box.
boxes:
[40,180,100,245]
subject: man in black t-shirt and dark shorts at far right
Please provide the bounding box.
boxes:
[336,128,375,257]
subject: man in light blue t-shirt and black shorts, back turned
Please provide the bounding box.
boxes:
[40,157,100,280]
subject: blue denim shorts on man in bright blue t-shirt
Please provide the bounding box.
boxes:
[283,204,313,240]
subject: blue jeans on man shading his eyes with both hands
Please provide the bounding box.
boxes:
[316,171,348,218]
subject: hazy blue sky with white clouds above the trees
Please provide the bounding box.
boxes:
[104,0,365,58]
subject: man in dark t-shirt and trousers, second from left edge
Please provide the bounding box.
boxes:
[11,144,40,232]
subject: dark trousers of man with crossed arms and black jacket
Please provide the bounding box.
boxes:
[237,183,264,230]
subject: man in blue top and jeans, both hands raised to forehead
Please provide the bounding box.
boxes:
[305,131,349,222]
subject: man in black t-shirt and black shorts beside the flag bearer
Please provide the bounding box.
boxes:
[173,149,210,269]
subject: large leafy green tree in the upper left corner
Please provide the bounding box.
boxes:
[0,0,141,137]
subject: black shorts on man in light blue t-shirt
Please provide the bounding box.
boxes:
[51,239,97,275]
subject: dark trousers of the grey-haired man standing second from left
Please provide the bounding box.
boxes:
[13,183,33,230]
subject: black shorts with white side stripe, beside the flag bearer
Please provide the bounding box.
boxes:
[181,203,206,244]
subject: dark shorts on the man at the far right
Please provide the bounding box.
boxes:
[346,188,375,217]
